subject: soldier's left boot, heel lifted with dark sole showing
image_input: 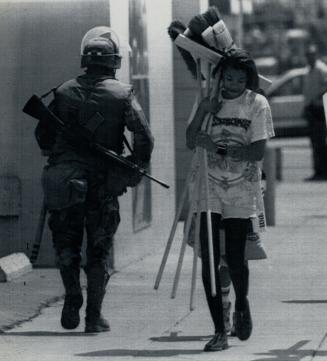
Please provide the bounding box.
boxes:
[60,266,83,330]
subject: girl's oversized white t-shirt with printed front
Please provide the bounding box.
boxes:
[190,90,274,218]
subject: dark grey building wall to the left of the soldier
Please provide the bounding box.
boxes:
[0,0,109,265]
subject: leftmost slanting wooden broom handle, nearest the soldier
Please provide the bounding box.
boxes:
[154,163,192,290]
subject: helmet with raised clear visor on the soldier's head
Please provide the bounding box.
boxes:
[81,26,122,69]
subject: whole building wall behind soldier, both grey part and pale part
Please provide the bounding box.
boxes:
[0,0,175,267]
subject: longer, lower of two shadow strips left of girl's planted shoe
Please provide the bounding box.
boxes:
[75,349,203,357]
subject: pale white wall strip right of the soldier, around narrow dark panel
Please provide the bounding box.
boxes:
[110,0,175,268]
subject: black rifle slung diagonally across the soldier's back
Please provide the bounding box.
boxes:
[23,95,169,188]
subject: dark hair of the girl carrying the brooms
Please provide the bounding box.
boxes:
[213,48,261,92]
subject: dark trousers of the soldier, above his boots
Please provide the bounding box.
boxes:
[49,169,120,314]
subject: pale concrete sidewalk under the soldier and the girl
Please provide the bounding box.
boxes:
[0,182,327,361]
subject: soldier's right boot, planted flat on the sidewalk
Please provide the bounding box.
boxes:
[85,268,110,333]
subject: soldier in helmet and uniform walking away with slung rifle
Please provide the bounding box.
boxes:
[35,26,153,333]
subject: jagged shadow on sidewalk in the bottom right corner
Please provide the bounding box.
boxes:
[252,335,327,361]
